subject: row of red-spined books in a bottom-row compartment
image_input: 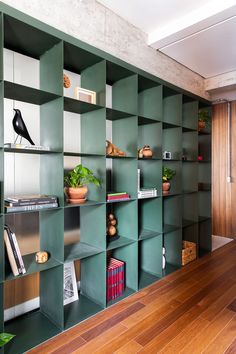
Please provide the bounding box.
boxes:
[107,258,125,302]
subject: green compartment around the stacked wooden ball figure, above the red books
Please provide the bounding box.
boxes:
[106,200,138,250]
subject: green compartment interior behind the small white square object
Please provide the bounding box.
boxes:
[162,127,183,160]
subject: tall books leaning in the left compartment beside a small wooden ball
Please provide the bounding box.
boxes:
[4,225,26,277]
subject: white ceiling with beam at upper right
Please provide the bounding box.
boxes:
[98,0,236,78]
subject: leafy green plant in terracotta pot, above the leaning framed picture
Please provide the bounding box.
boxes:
[64,164,100,203]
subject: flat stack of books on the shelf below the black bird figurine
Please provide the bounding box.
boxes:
[4,194,58,213]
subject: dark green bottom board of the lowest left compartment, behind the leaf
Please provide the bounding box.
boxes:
[4,311,60,354]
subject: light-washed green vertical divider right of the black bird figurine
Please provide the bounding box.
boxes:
[40,98,63,151]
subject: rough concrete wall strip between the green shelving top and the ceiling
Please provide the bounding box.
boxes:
[0,0,209,98]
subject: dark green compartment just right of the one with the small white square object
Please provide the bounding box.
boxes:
[182,131,198,162]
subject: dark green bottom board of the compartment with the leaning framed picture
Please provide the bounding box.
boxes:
[64,294,103,329]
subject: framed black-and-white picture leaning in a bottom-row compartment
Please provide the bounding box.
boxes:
[64,262,79,305]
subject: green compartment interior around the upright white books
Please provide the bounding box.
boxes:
[138,159,162,192]
